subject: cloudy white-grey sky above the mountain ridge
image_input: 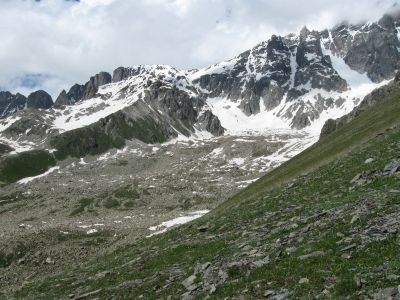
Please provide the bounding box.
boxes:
[0,0,400,96]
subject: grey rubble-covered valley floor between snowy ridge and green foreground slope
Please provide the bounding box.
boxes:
[0,132,312,290]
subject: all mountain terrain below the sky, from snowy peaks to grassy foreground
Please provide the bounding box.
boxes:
[0,10,400,299]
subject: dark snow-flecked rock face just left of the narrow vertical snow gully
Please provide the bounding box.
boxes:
[193,35,292,115]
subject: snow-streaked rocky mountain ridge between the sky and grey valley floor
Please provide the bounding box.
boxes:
[0,12,400,156]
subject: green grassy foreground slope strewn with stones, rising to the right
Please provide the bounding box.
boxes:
[12,89,400,299]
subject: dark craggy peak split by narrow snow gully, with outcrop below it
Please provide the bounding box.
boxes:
[193,28,348,125]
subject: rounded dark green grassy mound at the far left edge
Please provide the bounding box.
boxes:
[0,150,56,184]
